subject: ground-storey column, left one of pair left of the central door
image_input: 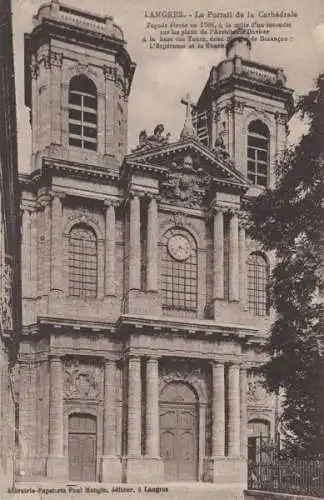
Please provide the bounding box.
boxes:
[128,356,142,456]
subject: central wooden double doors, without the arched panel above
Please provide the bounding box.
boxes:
[160,403,198,481]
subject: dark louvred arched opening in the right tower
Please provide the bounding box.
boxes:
[247,120,270,187]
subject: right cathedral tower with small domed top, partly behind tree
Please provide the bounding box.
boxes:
[197,30,292,194]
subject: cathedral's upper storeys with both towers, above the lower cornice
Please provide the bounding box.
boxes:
[22,1,292,342]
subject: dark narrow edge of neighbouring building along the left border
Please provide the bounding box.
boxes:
[0,0,21,492]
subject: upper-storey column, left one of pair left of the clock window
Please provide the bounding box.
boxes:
[129,195,141,290]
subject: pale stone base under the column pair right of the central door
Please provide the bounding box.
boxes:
[204,456,247,489]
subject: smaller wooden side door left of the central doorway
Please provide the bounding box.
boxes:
[69,414,97,481]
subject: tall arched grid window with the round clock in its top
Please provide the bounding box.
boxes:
[161,228,197,311]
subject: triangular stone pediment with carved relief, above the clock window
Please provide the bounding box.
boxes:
[125,138,250,206]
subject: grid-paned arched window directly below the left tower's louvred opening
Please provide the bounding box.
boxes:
[69,225,98,298]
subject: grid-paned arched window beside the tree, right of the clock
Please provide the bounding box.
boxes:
[248,253,269,316]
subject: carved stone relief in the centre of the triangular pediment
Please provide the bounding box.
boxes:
[161,155,211,208]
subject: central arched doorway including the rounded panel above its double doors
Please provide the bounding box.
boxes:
[160,382,198,481]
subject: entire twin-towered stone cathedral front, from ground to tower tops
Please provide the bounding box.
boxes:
[16,0,292,486]
